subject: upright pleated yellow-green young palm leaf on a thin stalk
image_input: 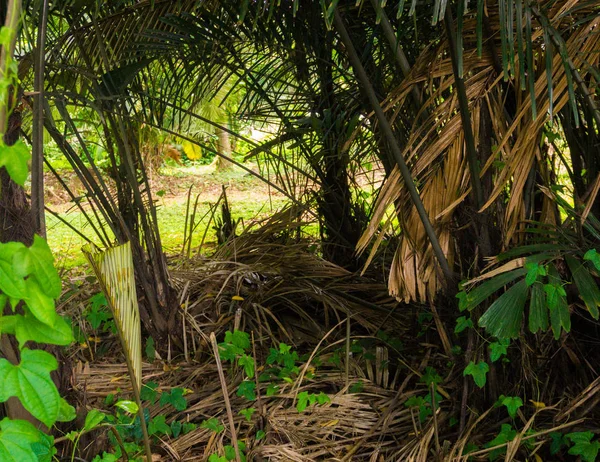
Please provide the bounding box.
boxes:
[82,242,152,461]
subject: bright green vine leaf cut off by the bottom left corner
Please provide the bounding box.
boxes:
[0,418,41,462]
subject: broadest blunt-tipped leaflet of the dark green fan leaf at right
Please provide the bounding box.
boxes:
[479,280,528,338]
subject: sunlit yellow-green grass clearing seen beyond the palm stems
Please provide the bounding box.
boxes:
[45,164,285,269]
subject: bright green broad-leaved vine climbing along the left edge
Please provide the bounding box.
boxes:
[0,1,75,462]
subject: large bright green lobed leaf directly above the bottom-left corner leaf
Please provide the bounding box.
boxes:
[0,348,60,427]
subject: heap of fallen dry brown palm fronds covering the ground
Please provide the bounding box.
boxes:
[63,222,600,461]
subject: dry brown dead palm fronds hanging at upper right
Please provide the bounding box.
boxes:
[357,2,600,301]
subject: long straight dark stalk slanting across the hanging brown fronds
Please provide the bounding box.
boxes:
[333,11,454,283]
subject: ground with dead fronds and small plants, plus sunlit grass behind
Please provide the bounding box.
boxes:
[46,161,600,462]
